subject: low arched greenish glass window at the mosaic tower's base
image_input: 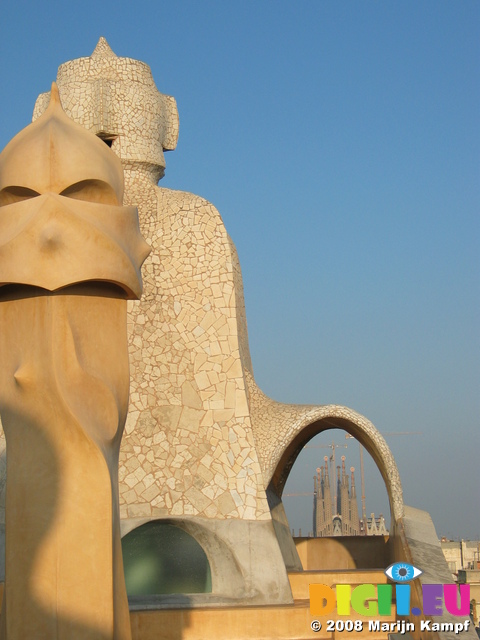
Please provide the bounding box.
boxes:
[122,520,212,596]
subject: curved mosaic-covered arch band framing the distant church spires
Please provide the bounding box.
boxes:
[268,405,403,521]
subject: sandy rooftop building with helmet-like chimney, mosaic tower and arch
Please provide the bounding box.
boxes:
[0,38,473,640]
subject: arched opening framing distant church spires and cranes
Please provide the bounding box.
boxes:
[281,428,392,570]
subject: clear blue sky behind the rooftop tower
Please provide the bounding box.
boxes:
[0,0,480,538]
